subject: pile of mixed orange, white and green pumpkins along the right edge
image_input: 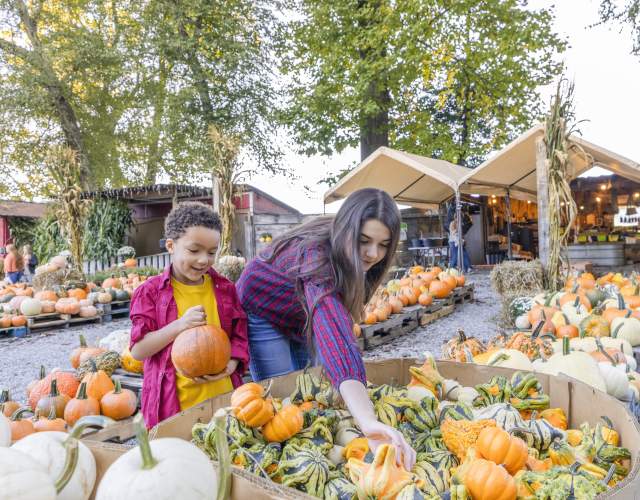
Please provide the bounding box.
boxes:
[443,273,640,400]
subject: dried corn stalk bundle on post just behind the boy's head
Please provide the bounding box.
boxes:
[209,125,240,255]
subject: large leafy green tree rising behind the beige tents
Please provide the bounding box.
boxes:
[280,0,565,166]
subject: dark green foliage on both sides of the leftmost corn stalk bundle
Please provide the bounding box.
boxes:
[32,199,133,262]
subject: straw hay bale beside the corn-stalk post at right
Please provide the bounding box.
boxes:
[491,260,544,327]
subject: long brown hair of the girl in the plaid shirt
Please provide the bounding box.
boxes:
[263,188,400,328]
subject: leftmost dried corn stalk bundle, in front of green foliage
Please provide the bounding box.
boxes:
[45,146,91,270]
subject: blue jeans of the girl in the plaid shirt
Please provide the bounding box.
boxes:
[247,314,309,382]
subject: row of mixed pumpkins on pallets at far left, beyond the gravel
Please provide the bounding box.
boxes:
[0,273,146,328]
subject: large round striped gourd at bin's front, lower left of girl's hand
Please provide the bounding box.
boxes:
[276,444,331,497]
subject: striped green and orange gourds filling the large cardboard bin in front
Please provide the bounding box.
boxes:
[192,357,630,500]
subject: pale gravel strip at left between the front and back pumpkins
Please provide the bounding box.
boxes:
[0,318,131,402]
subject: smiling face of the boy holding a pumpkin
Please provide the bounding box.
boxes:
[166,226,220,285]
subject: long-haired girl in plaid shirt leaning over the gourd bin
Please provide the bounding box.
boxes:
[236,189,415,470]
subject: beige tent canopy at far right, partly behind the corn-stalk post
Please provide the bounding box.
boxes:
[460,125,640,201]
